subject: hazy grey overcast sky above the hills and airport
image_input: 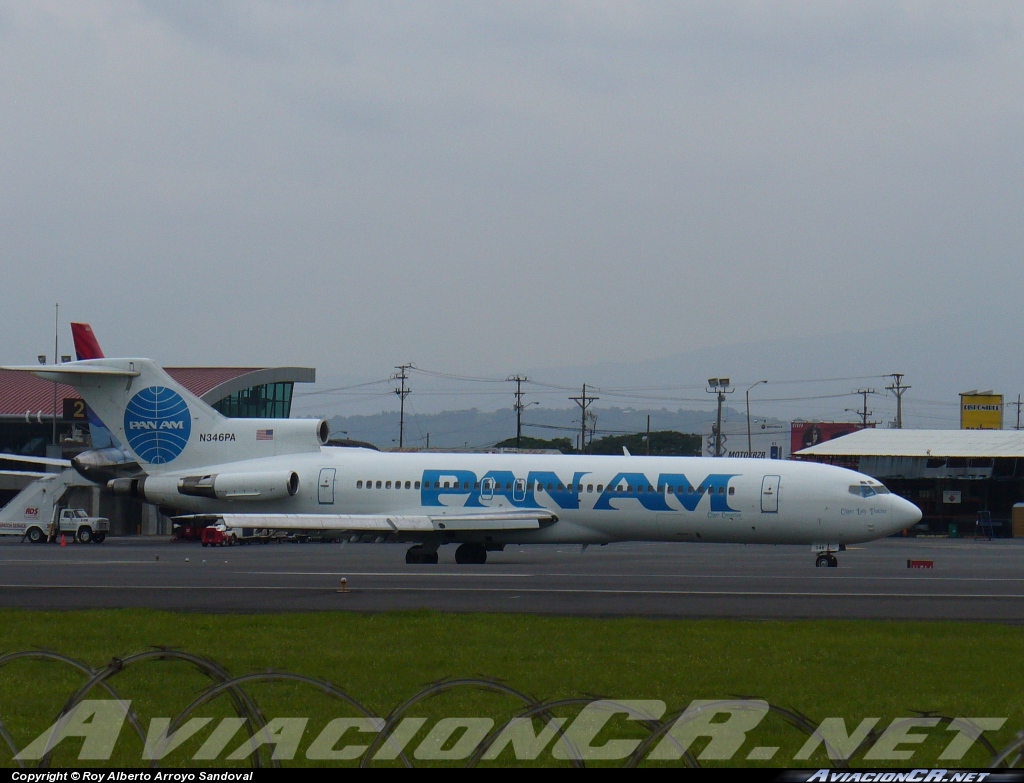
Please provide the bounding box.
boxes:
[0,0,1024,423]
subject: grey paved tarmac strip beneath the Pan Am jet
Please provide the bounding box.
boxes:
[0,538,1024,622]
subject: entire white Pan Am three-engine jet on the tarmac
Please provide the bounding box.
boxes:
[7,358,921,567]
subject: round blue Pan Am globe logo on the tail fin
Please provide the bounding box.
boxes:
[125,386,191,465]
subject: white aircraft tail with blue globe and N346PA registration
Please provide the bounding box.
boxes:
[2,358,329,475]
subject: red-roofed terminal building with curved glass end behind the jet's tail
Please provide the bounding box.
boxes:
[0,367,316,535]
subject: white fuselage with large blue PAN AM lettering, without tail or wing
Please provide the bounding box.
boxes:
[145,446,921,543]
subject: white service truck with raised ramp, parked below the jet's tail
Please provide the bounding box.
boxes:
[0,469,111,543]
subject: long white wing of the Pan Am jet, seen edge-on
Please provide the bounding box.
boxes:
[175,510,558,533]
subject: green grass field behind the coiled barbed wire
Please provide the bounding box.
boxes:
[0,610,1024,767]
